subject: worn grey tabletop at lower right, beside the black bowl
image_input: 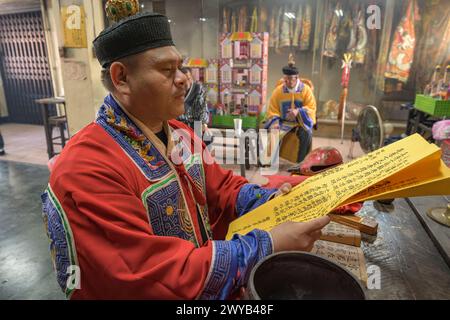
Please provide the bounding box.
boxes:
[360,197,450,299]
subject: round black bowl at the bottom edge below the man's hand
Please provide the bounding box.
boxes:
[247,251,365,300]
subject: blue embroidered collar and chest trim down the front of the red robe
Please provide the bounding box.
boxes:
[96,95,212,247]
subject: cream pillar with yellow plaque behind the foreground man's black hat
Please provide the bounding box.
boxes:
[45,0,107,135]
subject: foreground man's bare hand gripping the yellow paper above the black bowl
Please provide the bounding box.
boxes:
[270,216,330,252]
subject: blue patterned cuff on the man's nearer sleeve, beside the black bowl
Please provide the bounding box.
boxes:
[198,229,273,300]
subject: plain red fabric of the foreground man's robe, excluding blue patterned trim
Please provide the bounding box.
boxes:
[50,121,247,299]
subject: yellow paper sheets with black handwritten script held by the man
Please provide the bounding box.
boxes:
[227,134,450,239]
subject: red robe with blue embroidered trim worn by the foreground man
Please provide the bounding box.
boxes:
[42,95,276,299]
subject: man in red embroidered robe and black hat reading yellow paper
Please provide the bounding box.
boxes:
[42,7,329,299]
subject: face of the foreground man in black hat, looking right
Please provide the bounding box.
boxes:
[128,46,187,122]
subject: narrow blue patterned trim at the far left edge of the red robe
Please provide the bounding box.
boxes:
[41,185,80,299]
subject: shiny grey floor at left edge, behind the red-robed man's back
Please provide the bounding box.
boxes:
[0,161,64,300]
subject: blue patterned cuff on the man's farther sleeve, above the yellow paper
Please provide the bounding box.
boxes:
[236,184,278,217]
